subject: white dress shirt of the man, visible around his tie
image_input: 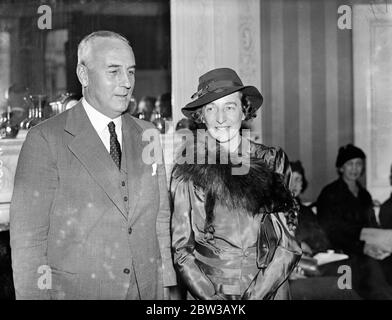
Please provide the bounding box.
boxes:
[82,97,122,153]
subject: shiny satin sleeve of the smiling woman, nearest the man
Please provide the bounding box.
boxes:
[170,178,220,300]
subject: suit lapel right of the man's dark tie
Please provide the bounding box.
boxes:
[122,114,145,224]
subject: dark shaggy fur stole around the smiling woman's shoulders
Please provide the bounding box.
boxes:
[173,139,296,233]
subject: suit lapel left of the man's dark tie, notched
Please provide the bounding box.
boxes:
[65,102,128,219]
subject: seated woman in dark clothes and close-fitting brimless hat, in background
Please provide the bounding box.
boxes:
[317,144,392,299]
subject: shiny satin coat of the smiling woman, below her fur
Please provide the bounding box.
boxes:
[170,142,301,299]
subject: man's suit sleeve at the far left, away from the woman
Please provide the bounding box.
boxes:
[10,129,58,299]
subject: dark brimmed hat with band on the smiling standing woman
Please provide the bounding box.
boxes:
[181,68,263,118]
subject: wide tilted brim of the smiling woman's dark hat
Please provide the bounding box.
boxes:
[181,86,263,118]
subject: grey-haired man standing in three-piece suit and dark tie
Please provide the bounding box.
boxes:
[10,31,176,299]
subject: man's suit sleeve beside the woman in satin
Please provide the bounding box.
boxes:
[156,152,177,287]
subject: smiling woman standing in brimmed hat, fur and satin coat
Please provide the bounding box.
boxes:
[170,68,301,299]
